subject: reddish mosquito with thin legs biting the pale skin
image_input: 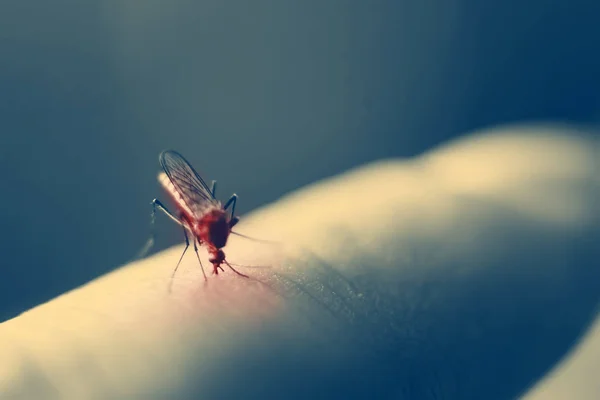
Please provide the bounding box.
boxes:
[147,150,248,280]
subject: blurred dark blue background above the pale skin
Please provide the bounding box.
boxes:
[0,0,600,320]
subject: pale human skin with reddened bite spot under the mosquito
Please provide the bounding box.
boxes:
[0,127,600,400]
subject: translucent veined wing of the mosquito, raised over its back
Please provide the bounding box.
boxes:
[158,150,220,217]
